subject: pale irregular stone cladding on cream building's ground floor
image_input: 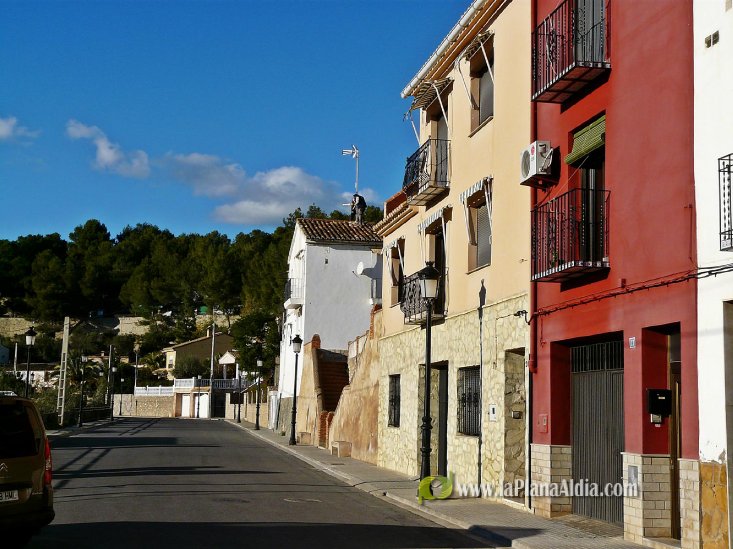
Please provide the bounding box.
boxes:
[377,294,529,490]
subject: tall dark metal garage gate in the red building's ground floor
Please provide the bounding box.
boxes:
[571,341,624,524]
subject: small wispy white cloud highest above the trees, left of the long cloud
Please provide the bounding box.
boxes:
[66,120,150,179]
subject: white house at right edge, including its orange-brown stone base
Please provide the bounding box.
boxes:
[692,0,733,547]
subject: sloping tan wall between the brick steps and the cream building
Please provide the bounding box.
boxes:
[329,312,382,464]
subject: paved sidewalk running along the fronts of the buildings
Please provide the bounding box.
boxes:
[227,420,641,549]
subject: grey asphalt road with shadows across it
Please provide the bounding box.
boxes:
[29,419,489,549]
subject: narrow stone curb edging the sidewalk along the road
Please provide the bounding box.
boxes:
[229,422,512,547]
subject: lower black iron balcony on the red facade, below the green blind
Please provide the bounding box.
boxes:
[532,189,609,282]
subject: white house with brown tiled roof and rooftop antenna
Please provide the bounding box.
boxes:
[271,218,382,426]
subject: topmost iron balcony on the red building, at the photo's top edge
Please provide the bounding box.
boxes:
[532,0,611,103]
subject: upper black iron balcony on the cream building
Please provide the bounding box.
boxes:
[402,139,450,206]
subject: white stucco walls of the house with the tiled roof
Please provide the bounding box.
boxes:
[278,223,382,398]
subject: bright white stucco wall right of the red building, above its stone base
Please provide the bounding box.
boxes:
[693,0,733,462]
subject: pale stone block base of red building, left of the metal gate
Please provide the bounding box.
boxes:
[531,444,573,518]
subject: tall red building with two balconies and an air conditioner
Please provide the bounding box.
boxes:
[522,0,699,547]
